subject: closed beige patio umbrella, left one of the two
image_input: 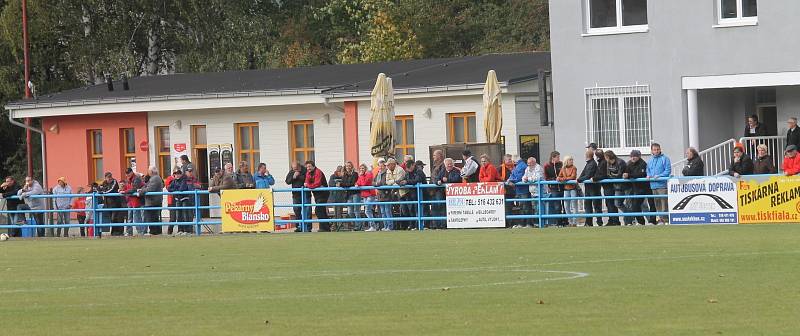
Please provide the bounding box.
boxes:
[370,73,394,159]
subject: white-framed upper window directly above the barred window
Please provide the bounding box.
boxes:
[586,0,647,34]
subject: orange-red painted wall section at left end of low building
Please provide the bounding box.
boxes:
[42,112,149,191]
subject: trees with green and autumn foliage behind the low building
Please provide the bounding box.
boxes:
[0,0,550,181]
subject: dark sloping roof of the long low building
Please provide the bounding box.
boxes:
[9,52,550,107]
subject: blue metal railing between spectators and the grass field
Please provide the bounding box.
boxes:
[0,177,724,239]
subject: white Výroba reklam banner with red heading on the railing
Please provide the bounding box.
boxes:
[446,182,506,229]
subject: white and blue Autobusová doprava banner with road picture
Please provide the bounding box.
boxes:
[668,176,738,224]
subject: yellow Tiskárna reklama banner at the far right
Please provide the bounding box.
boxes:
[738,176,800,224]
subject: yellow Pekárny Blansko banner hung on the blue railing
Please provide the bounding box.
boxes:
[220,189,275,232]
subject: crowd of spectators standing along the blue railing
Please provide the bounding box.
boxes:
[0,118,800,237]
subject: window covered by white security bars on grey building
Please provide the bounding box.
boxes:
[586,85,651,152]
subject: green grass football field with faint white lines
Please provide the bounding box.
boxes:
[0,225,800,335]
